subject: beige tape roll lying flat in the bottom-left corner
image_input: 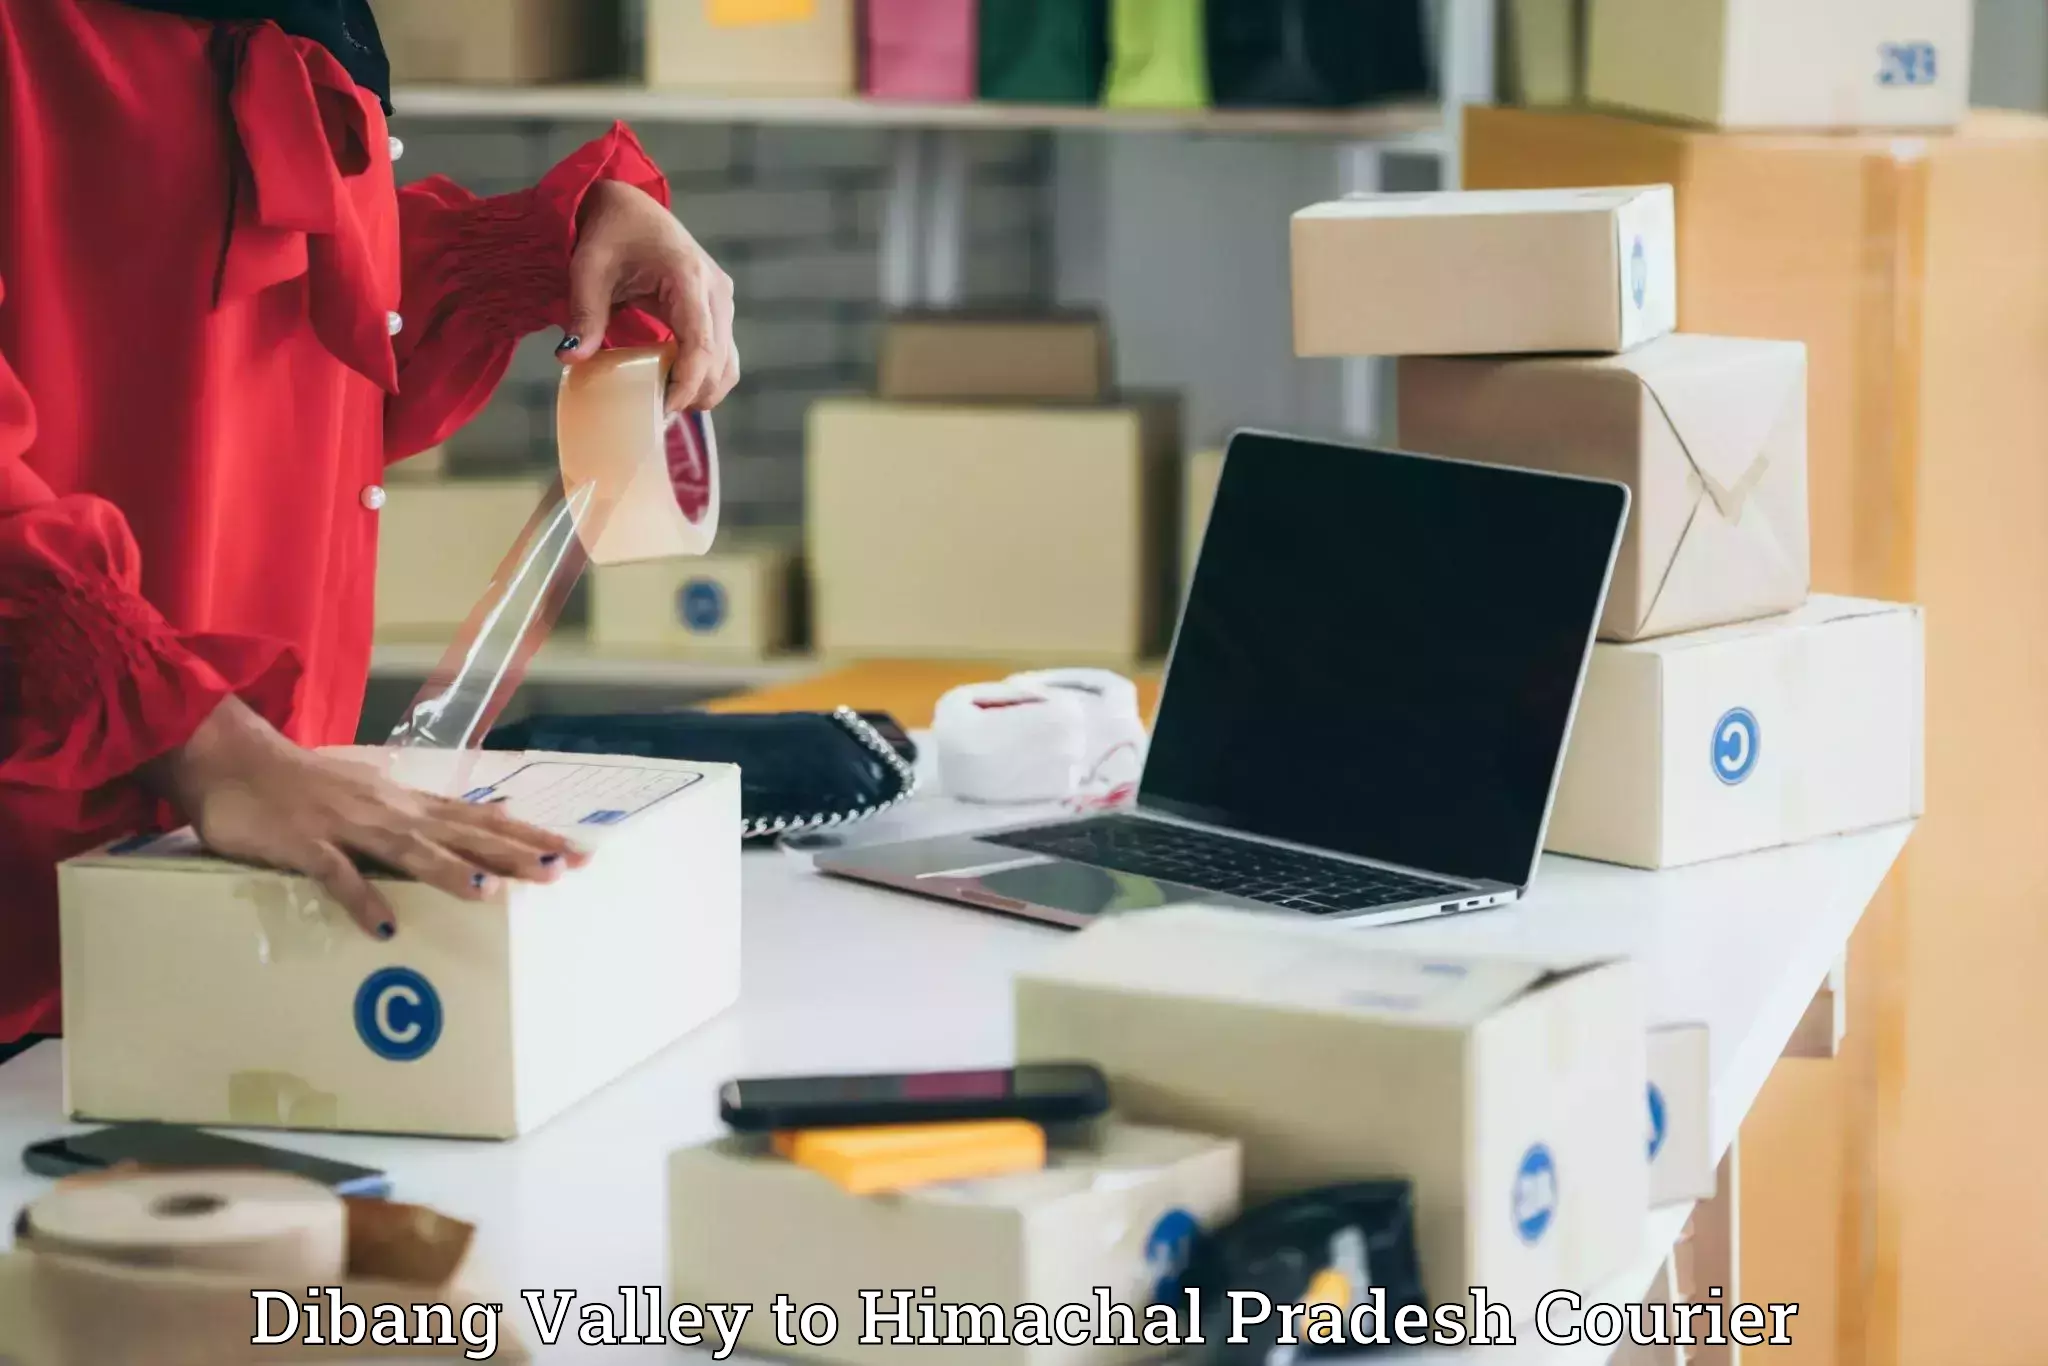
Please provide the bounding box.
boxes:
[20,1171,348,1286]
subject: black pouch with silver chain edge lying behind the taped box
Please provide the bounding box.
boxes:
[483,707,918,840]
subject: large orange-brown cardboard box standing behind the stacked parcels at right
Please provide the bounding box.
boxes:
[1464,109,2048,1362]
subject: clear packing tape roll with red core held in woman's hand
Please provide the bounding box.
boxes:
[555,342,719,565]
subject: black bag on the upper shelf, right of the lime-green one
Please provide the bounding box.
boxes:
[1208,0,1432,109]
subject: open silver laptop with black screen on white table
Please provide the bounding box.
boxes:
[817,432,1628,928]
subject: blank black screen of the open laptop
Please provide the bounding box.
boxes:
[1141,434,1628,887]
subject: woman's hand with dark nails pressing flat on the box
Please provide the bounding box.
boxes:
[143,698,588,940]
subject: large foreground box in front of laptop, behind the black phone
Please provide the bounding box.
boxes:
[1016,909,1649,1321]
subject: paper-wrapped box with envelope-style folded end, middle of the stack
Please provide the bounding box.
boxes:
[1399,334,1812,641]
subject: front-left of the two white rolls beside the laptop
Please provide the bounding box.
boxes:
[932,682,1087,805]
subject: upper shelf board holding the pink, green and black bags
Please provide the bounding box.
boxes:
[391,84,1444,143]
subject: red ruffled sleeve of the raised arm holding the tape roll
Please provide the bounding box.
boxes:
[385,123,668,461]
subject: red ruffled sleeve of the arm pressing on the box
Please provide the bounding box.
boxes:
[0,278,299,793]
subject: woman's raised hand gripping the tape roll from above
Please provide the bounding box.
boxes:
[555,180,739,412]
